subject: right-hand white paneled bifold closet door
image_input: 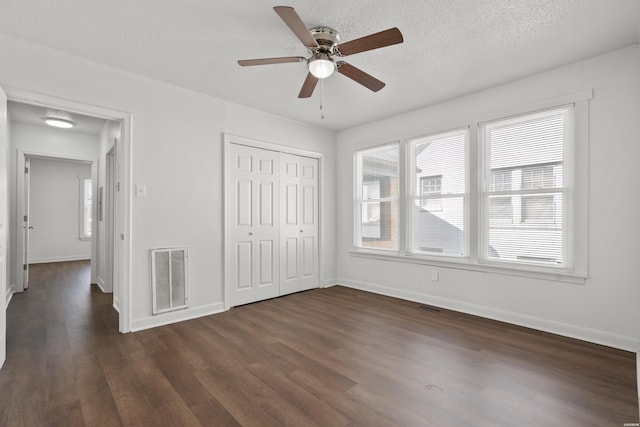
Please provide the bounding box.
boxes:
[280,153,319,295]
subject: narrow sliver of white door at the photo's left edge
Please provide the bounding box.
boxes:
[0,88,8,368]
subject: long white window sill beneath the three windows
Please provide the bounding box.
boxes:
[349,249,588,285]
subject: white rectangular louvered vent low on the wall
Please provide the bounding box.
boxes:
[151,248,188,314]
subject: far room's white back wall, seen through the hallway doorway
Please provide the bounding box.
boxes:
[29,157,91,263]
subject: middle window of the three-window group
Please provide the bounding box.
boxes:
[409,129,468,256]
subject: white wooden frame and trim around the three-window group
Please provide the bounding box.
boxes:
[349,89,593,284]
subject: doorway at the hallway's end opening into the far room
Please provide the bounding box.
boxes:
[15,153,97,292]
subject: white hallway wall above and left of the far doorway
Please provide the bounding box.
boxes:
[7,122,99,289]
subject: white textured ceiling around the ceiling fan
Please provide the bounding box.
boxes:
[0,0,640,129]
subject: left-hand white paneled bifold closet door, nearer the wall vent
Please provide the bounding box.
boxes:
[226,144,280,306]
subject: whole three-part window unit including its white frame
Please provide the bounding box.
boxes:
[353,94,592,283]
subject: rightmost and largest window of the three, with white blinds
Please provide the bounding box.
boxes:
[479,107,573,268]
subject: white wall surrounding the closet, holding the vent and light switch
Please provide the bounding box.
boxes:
[0,37,335,328]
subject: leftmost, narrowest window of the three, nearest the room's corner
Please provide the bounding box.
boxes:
[356,144,399,250]
